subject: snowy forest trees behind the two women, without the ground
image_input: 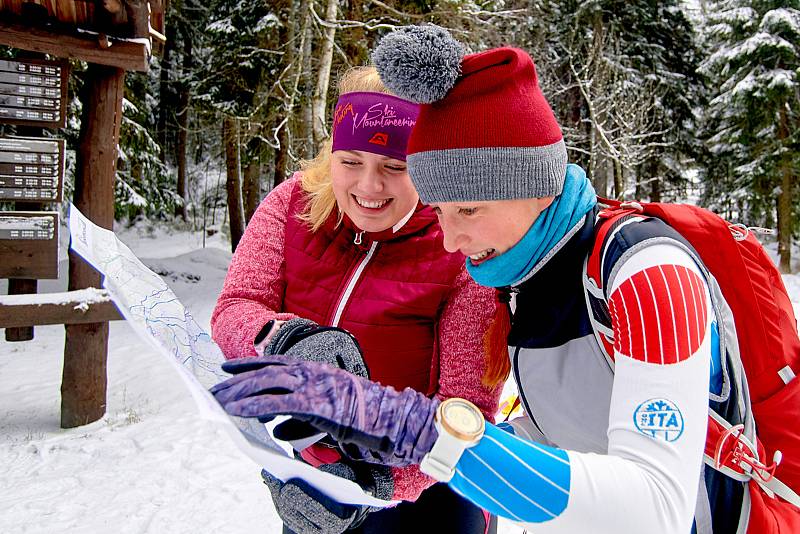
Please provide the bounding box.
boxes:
[0,0,800,272]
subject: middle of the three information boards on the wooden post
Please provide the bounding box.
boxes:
[0,137,65,202]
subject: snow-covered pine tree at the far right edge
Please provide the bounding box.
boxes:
[702,0,800,272]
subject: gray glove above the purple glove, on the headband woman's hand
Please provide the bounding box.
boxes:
[262,317,369,378]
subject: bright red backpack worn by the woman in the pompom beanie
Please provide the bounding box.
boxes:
[584,198,800,534]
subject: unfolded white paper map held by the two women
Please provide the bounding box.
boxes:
[69,205,392,507]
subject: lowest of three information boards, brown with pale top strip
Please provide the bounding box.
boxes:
[0,211,58,280]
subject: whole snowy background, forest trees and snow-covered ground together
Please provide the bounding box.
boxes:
[0,0,800,534]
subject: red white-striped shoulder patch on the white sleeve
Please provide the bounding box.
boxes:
[609,265,708,364]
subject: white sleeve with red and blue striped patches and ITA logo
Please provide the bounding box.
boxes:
[450,245,714,534]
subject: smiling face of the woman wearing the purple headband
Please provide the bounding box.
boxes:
[331,150,419,232]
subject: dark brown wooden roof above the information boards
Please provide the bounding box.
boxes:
[0,0,166,72]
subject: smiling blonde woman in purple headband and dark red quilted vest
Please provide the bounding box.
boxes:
[211,67,508,534]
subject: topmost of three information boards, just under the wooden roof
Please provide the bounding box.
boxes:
[0,59,68,128]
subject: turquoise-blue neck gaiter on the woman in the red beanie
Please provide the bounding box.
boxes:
[467,164,597,287]
